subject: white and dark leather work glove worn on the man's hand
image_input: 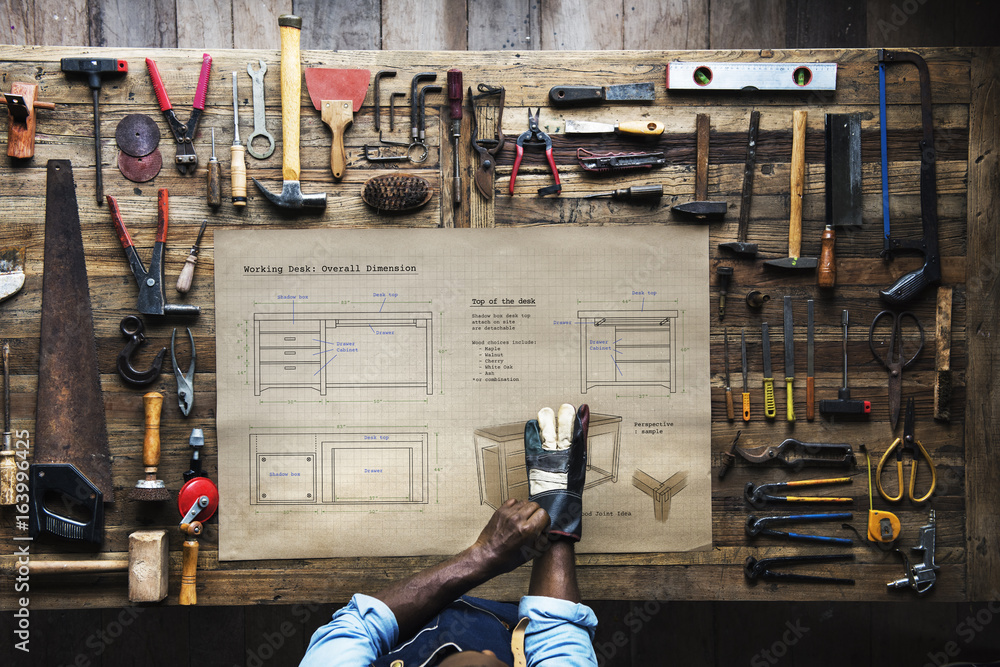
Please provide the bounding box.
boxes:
[524,403,590,542]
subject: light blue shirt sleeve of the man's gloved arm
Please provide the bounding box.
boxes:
[518,595,597,667]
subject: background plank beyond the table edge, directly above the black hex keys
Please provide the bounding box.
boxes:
[382,0,469,51]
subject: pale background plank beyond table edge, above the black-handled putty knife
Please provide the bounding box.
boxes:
[541,0,625,51]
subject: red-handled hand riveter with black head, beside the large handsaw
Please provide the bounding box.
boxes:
[107,188,201,317]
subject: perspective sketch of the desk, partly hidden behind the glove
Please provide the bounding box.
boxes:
[473,413,622,509]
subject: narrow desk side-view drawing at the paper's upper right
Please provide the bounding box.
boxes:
[577,310,677,394]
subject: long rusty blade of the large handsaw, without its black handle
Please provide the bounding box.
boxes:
[34,160,114,502]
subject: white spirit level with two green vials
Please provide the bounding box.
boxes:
[667,61,837,90]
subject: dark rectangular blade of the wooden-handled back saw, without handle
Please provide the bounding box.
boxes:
[826,113,862,227]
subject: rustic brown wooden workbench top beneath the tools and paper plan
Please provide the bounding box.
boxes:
[0,47,1000,608]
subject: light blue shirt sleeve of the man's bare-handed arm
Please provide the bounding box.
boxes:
[299,594,399,667]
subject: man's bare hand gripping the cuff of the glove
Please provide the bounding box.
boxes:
[472,498,549,576]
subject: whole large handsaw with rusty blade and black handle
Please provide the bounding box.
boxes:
[30,160,114,544]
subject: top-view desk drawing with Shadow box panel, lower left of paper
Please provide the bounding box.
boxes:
[250,430,428,505]
